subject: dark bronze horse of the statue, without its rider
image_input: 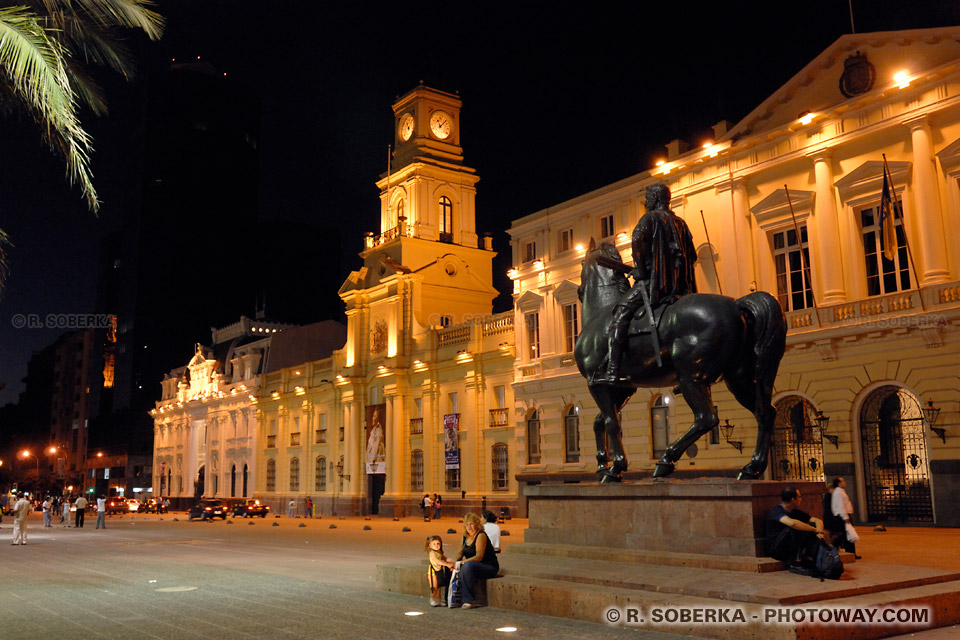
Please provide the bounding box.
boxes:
[574,242,787,482]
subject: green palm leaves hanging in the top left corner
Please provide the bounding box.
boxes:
[0,0,163,212]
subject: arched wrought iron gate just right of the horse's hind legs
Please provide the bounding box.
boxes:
[771,396,824,482]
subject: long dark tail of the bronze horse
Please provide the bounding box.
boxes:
[737,291,787,412]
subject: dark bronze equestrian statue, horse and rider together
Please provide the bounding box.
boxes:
[574,184,787,482]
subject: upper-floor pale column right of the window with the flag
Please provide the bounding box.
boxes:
[904,115,950,286]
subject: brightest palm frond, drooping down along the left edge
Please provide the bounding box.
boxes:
[0,7,100,211]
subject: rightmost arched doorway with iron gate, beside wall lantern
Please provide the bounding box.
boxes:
[860,385,933,522]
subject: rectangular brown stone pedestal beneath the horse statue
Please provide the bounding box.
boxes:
[524,478,825,558]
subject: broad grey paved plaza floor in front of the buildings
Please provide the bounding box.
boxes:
[0,513,960,640]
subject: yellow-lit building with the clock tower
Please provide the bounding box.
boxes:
[258,85,517,516]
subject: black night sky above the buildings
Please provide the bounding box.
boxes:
[0,0,960,404]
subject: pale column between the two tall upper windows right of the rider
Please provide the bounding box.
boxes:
[810,149,847,304]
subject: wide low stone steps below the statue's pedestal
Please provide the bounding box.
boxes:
[377,553,960,640]
